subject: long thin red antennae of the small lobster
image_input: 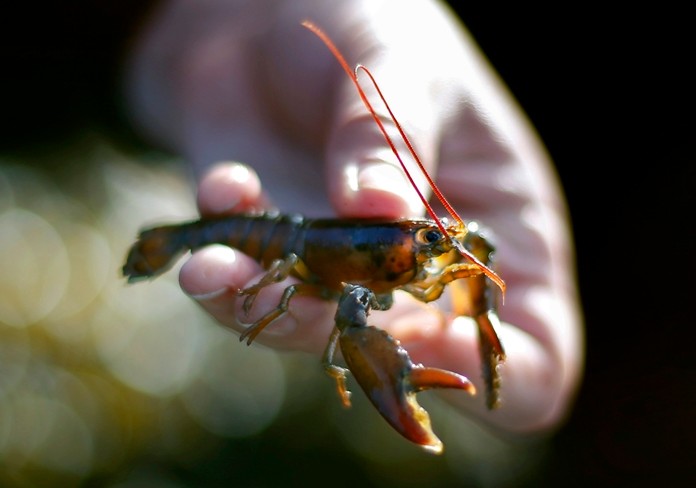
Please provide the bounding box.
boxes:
[302,20,505,296]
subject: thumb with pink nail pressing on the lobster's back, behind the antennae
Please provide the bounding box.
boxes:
[318,18,442,217]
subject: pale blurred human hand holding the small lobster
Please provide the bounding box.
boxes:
[128,0,584,433]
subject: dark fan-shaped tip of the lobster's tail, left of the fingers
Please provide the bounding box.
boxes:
[123,225,190,283]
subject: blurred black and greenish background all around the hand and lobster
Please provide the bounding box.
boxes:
[0,0,696,488]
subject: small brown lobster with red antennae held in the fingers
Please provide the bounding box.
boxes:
[123,21,505,453]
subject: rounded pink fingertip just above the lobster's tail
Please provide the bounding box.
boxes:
[197,161,270,217]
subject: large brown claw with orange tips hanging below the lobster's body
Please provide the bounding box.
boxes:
[325,285,476,454]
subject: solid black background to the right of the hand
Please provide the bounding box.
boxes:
[459,4,696,486]
